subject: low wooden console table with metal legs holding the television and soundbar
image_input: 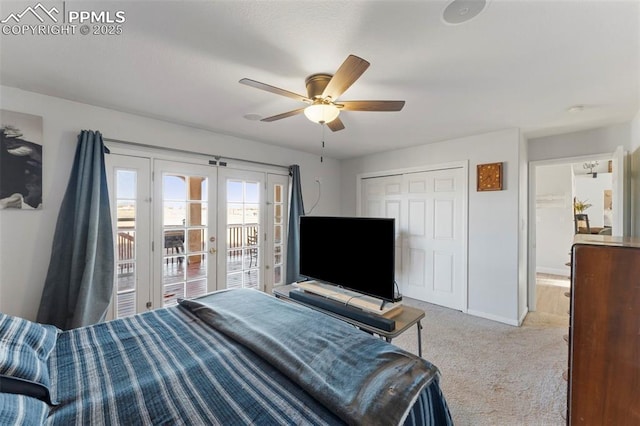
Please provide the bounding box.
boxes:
[273,284,424,357]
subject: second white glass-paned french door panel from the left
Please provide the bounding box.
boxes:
[153,160,217,307]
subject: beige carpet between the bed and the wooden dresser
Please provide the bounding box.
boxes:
[393,299,568,426]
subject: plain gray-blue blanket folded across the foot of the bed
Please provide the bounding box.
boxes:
[180,289,439,425]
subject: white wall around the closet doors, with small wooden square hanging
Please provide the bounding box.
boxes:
[342,129,526,325]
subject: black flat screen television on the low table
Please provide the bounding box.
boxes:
[300,216,400,302]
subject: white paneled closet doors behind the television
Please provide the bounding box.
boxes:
[361,167,467,311]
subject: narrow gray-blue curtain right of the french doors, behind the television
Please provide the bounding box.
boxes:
[286,164,304,284]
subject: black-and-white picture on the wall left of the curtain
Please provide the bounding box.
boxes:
[0,109,42,210]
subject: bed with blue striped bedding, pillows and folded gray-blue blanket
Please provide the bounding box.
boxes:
[0,290,452,425]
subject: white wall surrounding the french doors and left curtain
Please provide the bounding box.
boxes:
[0,86,340,319]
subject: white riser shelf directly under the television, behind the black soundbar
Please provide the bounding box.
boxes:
[295,280,402,315]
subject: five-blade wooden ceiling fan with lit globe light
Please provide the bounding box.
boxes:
[240,55,404,132]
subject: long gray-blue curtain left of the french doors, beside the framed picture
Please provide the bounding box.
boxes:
[37,130,114,330]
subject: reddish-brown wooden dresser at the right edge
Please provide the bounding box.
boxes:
[567,235,640,426]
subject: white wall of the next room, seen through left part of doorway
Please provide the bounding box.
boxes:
[535,164,574,276]
